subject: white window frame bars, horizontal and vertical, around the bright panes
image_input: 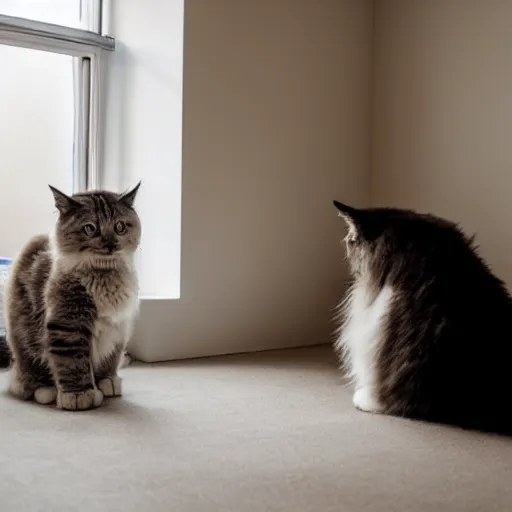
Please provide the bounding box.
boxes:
[0,0,115,192]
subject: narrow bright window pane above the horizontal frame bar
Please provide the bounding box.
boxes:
[0,0,82,28]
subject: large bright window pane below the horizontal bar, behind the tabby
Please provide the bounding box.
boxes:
[0,45,74,257]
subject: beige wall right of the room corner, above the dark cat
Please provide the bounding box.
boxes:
[371,0,512,286]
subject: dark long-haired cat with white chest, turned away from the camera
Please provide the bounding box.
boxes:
[334,201,512,435]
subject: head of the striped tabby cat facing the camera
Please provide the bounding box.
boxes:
[50,182,141,258]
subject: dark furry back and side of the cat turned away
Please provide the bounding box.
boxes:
[375,215,512,431]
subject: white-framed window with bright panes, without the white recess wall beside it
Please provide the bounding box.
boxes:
[0,0,114,257]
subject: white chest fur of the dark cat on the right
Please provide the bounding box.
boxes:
[338,282,393,390]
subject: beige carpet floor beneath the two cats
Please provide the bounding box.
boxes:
[0,347,512,512]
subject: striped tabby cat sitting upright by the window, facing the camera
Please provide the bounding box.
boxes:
[6,183,141,410]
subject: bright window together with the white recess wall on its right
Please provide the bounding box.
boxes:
[0,0,184,299]
